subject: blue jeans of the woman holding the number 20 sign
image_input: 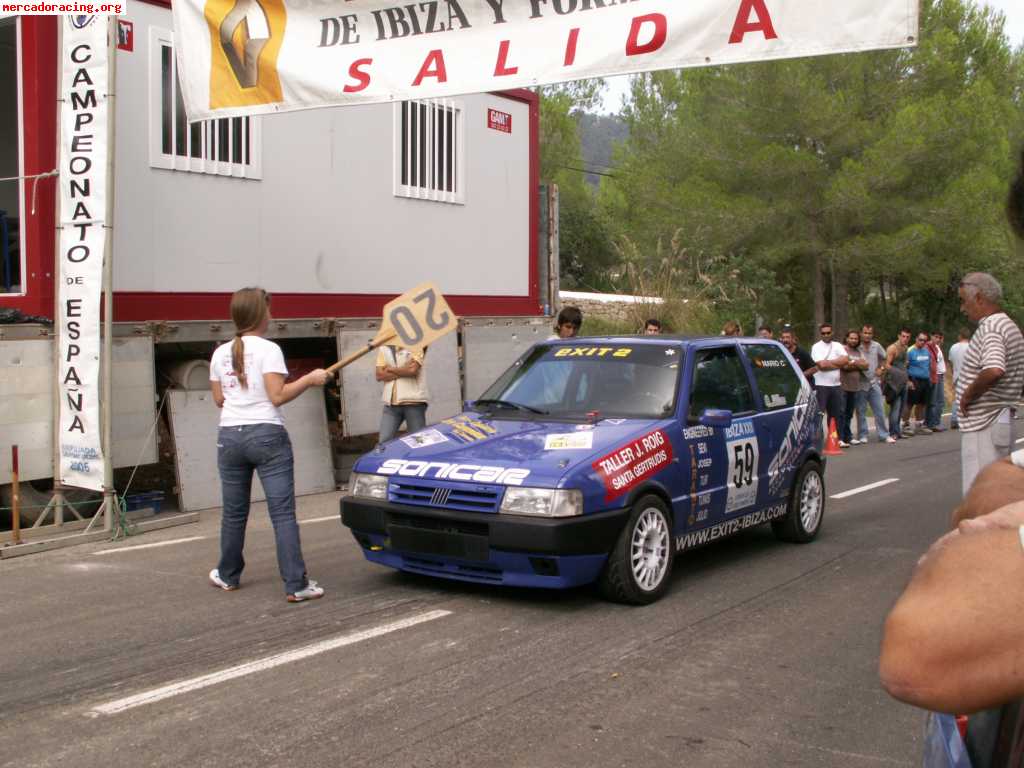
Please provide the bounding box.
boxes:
[217,424,308,595]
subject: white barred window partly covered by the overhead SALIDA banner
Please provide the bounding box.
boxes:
[150,30,262,179]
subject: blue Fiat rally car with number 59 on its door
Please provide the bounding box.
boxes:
[341,336,825,603]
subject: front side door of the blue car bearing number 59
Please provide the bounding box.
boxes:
[683,343,760,527]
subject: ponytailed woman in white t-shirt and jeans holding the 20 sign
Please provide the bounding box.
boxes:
[210,288,331,603]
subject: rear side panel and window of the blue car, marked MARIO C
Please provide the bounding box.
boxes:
[742,342,814,506]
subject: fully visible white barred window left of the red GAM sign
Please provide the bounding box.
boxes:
[394,98,465,203]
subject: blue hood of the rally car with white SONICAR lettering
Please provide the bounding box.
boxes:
[354,412,668,487]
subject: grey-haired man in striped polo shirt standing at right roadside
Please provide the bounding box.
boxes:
[956,272,1024,496]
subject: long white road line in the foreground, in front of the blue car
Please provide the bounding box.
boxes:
[85,610,452,717]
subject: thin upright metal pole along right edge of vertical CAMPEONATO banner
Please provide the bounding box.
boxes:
[100,14,118,531]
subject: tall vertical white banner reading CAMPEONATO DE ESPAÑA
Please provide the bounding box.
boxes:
[56,16,110,490]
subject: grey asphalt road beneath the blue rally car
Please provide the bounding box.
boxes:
[0,432,974,768]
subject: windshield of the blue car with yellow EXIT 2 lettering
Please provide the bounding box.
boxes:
[477,340,683,419]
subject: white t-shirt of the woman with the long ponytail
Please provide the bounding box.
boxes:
[210,336,288,427]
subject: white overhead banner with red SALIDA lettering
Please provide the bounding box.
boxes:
[172,0,918,120]
